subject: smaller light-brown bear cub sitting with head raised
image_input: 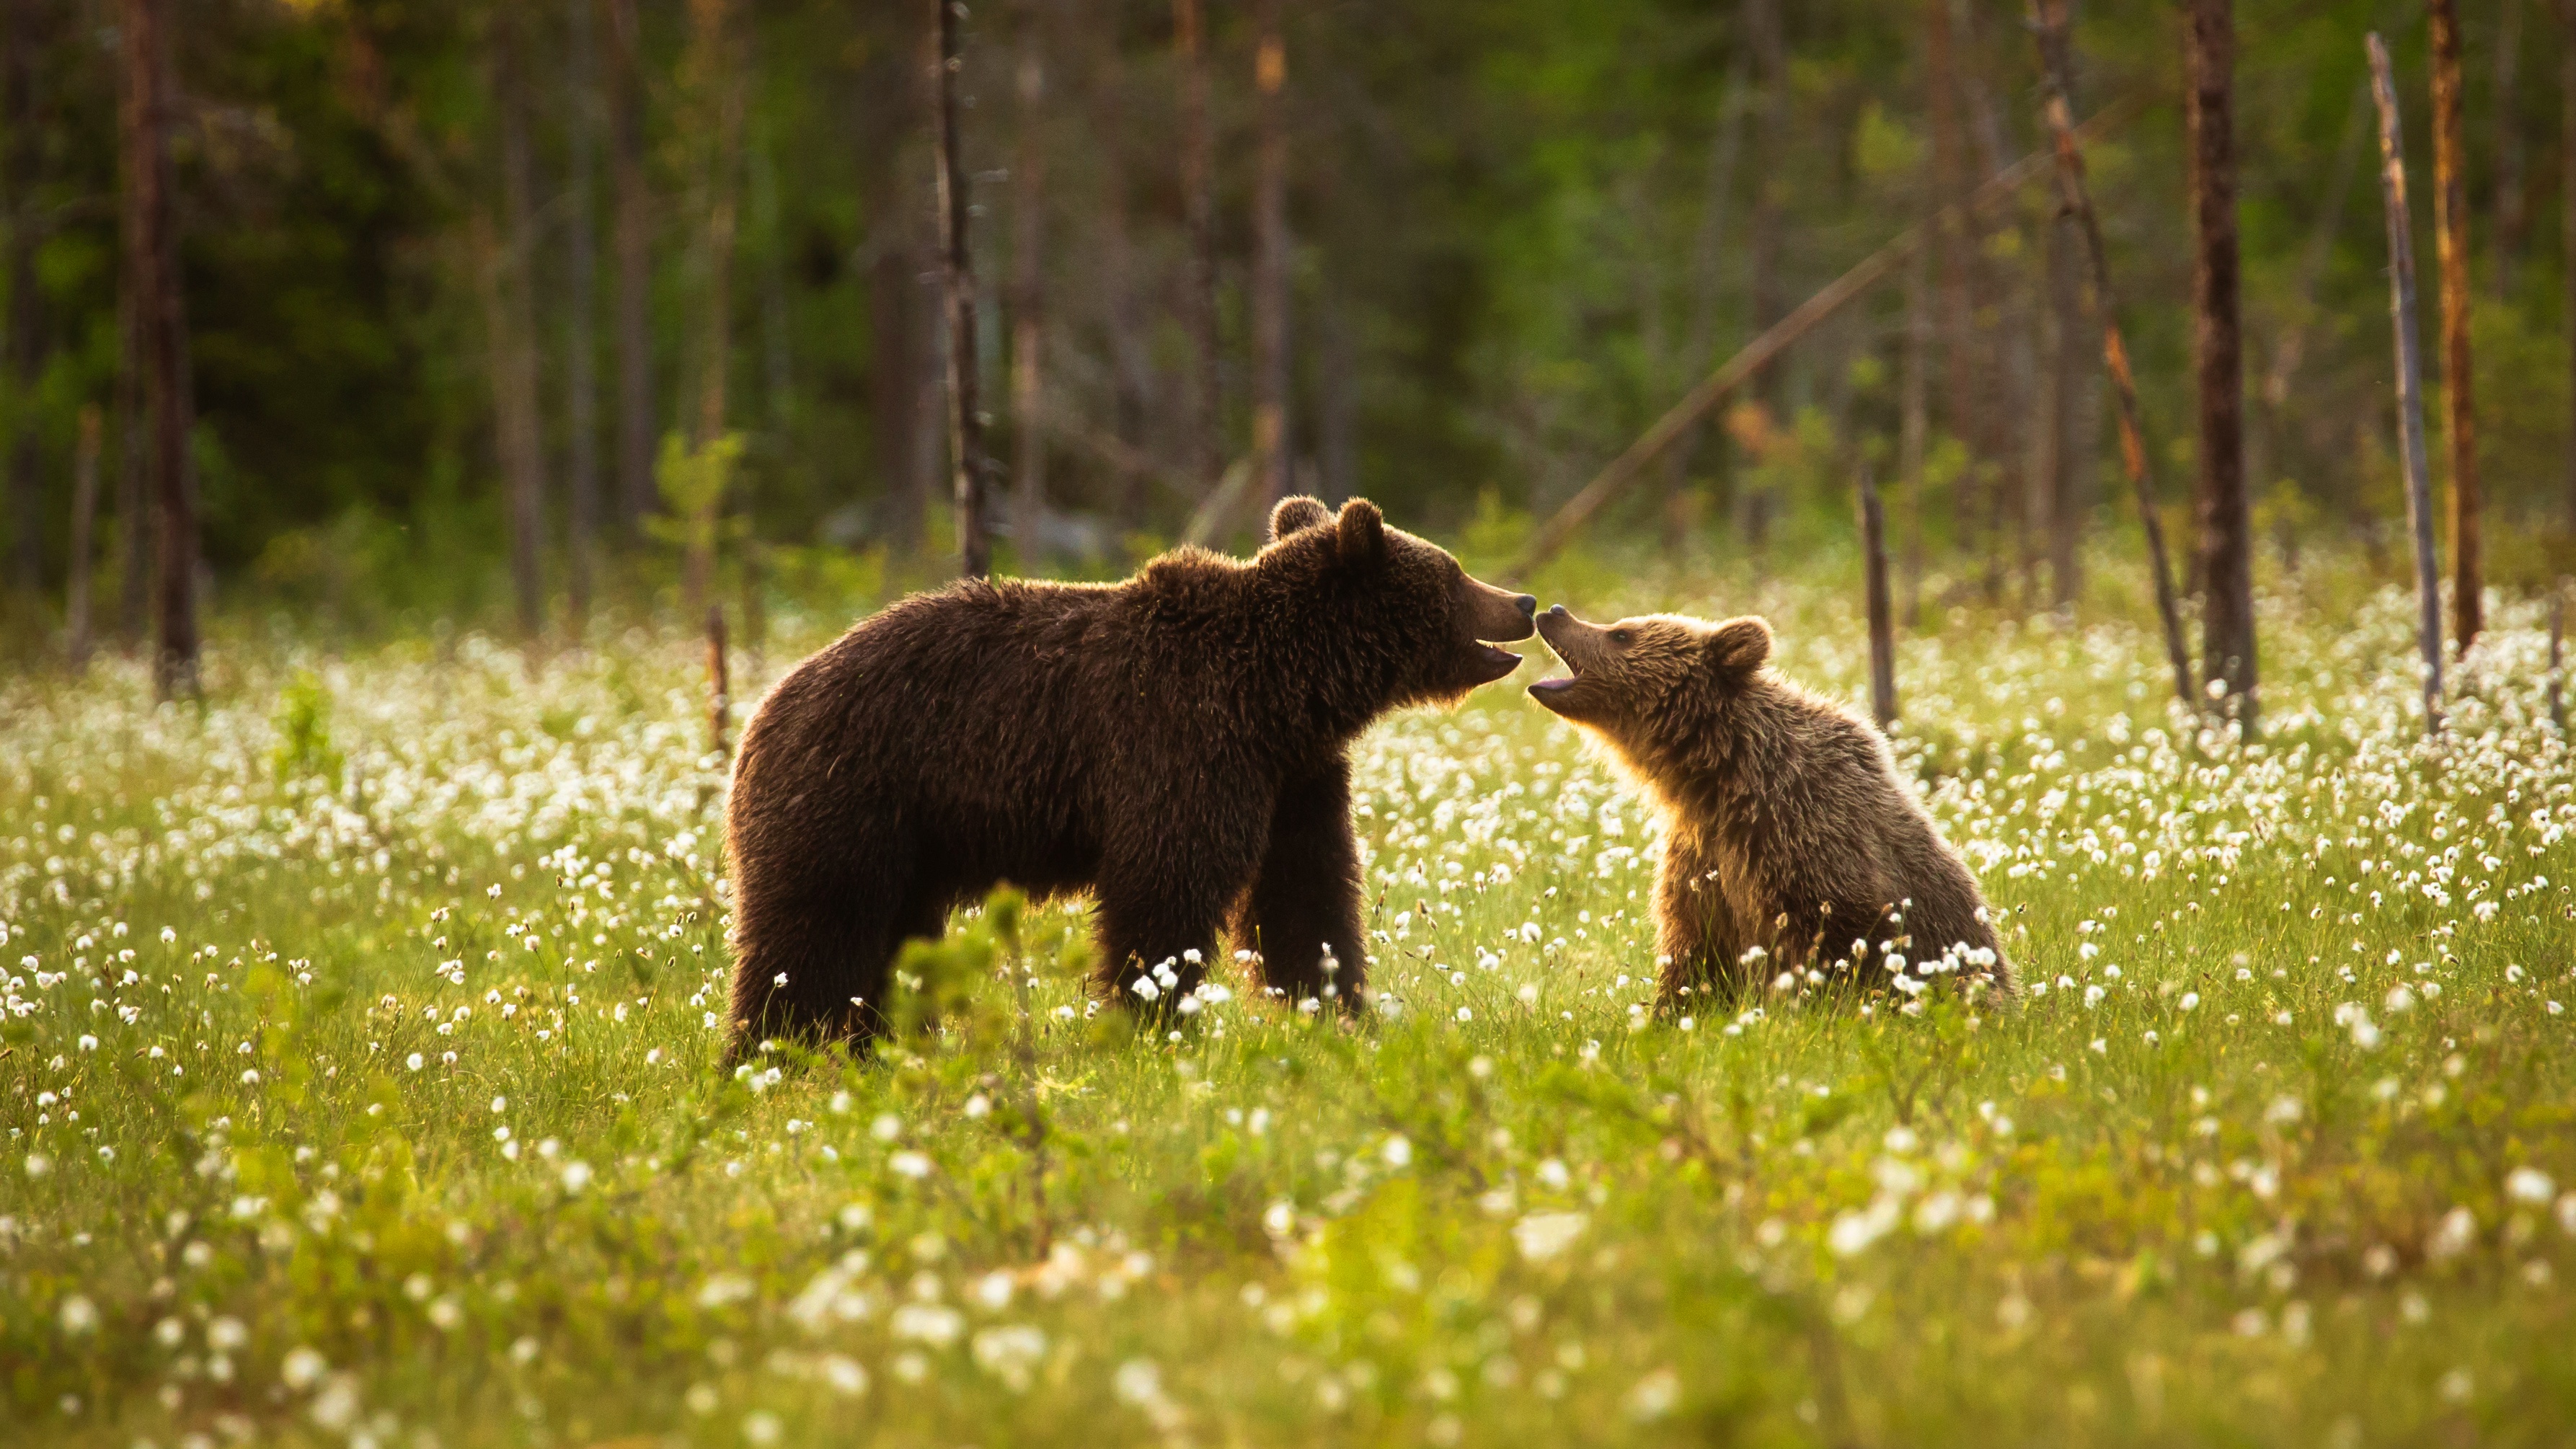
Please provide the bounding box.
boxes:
[1530,605,2014,1009]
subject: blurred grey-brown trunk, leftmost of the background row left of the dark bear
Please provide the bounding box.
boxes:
[497,5,546,638]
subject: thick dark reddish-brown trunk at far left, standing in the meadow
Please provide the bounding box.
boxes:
[118,0,198,700]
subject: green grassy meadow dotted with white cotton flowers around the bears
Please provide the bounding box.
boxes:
[0,561,2576,1449]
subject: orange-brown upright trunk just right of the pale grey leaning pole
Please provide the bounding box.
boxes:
[2427,0,2486,654]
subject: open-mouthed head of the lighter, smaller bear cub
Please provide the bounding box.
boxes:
[1530,605,1770,746]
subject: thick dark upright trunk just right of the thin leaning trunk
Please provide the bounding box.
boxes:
[2185,0,2256,733]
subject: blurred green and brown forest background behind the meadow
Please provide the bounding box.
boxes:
[0,0,2576,646]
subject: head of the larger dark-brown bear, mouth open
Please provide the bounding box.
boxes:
[1257,497,1538,718]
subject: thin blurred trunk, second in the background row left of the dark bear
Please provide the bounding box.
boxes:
[564,0,601,622]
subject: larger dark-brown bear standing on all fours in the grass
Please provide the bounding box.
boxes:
[727,497,1538,1058]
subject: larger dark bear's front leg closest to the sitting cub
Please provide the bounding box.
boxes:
[1234,759,1368,1009]
